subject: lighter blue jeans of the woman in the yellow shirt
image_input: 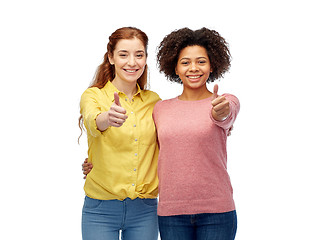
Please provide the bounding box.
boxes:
[82,197,158,240]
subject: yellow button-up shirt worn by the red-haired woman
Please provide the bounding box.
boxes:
[80,82,160,200]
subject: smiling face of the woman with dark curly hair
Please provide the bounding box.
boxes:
[176,45,211,89]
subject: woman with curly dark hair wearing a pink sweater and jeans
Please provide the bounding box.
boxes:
[153,28,240,240]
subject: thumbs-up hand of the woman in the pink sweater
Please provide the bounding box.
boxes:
[211,84,230,121]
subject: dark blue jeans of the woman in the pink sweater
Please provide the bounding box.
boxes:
[159,211,237,240]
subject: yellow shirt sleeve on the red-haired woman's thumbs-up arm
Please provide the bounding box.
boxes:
[80,88,102,137]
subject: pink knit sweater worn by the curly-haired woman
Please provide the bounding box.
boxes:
[153,94,240,216]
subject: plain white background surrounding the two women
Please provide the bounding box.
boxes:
[0,0,322,240]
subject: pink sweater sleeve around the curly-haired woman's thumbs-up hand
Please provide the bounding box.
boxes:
[210,93,240,132]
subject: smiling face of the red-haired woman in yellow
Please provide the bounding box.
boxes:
[109,38,146,84]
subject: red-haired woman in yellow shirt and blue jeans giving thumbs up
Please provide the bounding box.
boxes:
[80,27,160,240]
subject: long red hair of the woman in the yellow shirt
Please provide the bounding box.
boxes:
[78,27,149,140]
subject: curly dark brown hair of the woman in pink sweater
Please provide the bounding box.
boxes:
[157,27,231,83]
